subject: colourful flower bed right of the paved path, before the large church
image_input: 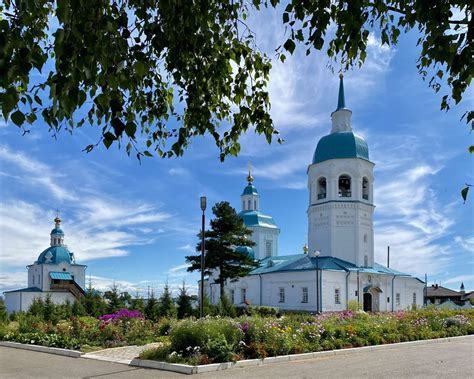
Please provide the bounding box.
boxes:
[140,309,474,365]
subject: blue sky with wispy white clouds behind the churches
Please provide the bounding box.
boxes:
[0,7,474,294]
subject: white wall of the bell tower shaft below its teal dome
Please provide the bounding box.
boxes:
[308,158,374,266]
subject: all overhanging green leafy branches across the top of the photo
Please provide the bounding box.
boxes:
[0,0,468,168]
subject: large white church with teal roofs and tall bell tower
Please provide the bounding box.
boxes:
[205,75,425,312]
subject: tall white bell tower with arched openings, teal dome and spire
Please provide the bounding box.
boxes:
[308,74,375,267]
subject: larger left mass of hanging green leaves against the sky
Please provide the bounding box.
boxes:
[0,0,276,159]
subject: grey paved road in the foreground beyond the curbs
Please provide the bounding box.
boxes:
[0,336,474,379]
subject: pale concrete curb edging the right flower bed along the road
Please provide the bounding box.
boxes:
[128,335,474,375]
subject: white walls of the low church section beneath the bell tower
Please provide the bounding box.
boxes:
[211,270,424,312]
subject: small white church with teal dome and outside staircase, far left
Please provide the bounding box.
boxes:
[4,216,87,314]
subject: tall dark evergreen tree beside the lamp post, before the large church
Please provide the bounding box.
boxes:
[186,201,258,298]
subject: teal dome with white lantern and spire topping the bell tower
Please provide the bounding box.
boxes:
[312,74,369,164]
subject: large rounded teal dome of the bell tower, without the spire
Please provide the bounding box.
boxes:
[313,131,369,164]
